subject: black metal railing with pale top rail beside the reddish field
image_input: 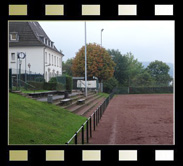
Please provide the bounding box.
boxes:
[66,93,114,145]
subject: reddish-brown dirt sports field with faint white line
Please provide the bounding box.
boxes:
[89,94,173,145]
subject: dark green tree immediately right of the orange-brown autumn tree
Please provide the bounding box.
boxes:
[108,49,129,85]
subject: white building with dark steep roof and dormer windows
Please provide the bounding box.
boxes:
[8,22,64,81]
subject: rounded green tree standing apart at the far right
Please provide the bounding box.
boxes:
[146,60,172,86]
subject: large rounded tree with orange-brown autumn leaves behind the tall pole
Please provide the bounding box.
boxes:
[72,43,115,82]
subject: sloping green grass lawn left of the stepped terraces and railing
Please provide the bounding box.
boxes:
[9,93,86,145]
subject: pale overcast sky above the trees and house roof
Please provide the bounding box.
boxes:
[39,21,175,64]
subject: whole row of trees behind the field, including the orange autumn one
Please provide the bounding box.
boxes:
[62,43,173,92]
